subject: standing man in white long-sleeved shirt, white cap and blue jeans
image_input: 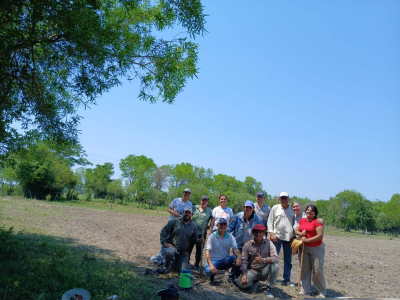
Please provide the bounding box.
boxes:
[267,192,295,286]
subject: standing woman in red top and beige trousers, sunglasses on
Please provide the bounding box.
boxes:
[296,205,326,298]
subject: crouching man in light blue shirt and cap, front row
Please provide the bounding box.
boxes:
[204,218,241,283]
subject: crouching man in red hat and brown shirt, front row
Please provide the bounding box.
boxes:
[237,225,279,298]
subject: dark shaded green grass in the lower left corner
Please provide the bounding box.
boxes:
[0,227,164,299]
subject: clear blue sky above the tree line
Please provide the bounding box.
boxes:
[76,0,400,201]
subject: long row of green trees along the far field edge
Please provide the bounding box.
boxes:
[0,141,400,234]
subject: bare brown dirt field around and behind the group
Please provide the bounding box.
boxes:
[0,201,400,299]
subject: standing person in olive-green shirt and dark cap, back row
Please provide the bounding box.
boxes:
[189,195,212,271]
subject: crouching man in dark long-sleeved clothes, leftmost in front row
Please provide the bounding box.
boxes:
[160,206,205,272]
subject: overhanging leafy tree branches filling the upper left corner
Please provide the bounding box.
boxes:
[0,0,205,154]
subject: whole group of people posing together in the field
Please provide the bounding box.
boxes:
[151,188,326,298]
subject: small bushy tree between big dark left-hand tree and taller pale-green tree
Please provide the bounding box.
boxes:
[85,163,114,198]
